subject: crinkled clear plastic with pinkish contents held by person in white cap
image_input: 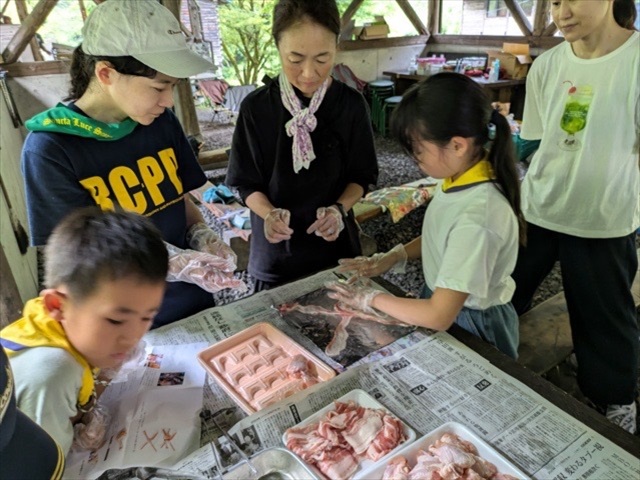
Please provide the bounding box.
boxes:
[165,242,247,293]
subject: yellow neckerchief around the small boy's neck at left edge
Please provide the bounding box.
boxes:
[0,297,97,408]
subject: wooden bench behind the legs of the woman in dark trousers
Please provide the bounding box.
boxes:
[518,249,640,375]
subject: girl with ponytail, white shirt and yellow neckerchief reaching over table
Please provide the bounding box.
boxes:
[328,72,526,358]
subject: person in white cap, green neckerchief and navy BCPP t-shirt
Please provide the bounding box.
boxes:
[22,0,237,327]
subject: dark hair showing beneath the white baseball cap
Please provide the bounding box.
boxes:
[64,44,158,102]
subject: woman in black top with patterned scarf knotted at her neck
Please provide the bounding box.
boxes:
[226,0,378,291]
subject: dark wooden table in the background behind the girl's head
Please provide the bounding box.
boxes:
[382,70,526,119]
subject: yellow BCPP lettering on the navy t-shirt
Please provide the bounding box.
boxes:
[80,148,184,215]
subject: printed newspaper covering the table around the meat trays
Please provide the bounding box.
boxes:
[86,271,640,480]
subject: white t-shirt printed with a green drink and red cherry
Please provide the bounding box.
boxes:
[521,32,640,238]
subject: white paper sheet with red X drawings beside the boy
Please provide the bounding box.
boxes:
[65,343,207,478]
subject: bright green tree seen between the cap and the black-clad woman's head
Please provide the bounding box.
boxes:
[218,0,280,85]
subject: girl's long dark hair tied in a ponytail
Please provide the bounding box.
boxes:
[391,72,526,245]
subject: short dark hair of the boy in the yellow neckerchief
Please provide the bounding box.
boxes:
[45,207,169,301]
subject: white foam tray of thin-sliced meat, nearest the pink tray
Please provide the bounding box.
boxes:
[282,389,416,480]
